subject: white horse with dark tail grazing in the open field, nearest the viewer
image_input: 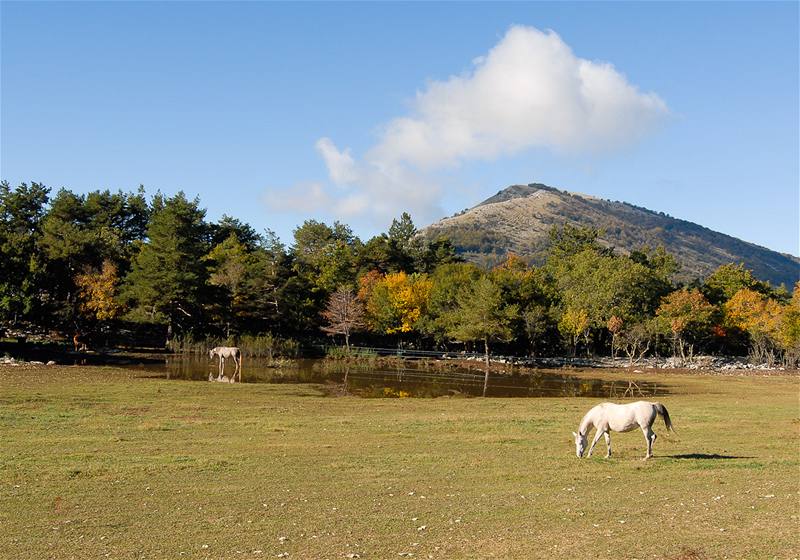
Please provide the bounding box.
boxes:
[572,401,675,460]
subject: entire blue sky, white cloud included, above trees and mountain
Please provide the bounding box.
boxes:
[0,2,800,255]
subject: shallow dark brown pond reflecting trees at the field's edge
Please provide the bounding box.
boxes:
[131,358,670,398]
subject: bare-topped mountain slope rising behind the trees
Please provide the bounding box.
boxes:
[420,183,800,289]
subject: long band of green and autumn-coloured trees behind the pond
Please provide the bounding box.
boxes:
[0,182,800,366]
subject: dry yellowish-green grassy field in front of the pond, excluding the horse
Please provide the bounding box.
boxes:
[0,366,800,559]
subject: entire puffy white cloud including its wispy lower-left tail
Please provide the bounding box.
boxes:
[272,26,668,229]
